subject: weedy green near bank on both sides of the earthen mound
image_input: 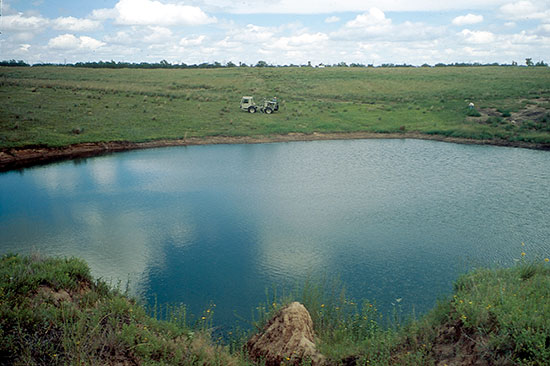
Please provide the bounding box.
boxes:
[0,254,550,366]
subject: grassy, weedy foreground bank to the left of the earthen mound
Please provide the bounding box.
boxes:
[0,255,245,365]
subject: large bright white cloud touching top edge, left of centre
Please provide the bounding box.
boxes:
[113,0,216,26]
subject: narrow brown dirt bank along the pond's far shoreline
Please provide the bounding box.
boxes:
[0,132,550,172]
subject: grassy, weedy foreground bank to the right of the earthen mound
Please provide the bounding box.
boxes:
[247,259,550,365]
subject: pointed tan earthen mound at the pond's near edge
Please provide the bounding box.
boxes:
[246,302,326,366]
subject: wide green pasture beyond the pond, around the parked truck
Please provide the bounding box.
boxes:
[0,67,550,148]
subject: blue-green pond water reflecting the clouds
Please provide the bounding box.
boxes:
[0,140,550,325]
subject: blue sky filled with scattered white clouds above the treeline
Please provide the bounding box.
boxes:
[0,0,550,65]
